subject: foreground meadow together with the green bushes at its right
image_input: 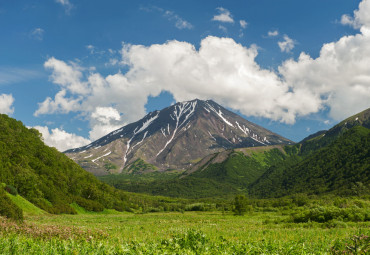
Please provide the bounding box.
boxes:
[0,195,370,254]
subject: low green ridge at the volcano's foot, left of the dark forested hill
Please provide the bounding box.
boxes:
[100,145,289,198]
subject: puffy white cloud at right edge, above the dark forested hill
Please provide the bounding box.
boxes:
[279,24,370,120]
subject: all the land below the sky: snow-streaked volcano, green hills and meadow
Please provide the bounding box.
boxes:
[0,100,370,254]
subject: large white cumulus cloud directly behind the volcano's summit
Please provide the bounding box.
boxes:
[38,36,306,126]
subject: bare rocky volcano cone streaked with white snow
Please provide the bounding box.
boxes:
[65,99,293,175]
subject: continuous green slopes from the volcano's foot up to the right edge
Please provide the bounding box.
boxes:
[102,106,370,198]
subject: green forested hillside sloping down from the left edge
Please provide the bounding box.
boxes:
[0,114,134,213]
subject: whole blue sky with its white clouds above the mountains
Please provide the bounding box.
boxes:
[0,0,370,150]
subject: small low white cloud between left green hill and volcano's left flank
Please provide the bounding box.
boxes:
[33,126,91,151]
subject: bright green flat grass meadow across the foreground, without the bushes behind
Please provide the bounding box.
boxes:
[0,211,370,254]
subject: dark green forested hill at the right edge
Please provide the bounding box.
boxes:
[250,126,370,197]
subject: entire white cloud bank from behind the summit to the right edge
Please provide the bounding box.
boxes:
[37,0,370,143]
